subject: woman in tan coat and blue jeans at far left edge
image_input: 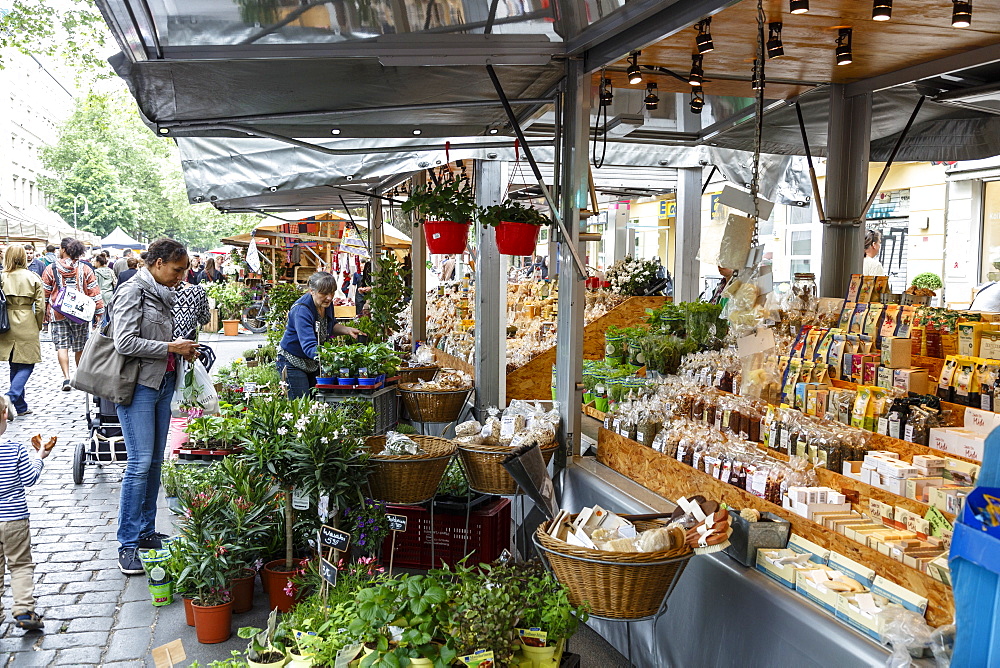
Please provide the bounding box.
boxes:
[0,246,45,415]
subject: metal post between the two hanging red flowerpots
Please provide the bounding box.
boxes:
[474,160,507,420]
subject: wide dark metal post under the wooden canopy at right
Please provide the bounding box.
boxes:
[820,84,872,297]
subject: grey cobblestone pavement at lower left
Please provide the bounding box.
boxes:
[0,336,267,668]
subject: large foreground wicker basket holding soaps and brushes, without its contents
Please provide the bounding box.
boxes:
[534,521,693,619]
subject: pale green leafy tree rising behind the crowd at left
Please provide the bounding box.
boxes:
[41,92,253,248]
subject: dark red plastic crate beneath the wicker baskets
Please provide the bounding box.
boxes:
[382,497,511,568]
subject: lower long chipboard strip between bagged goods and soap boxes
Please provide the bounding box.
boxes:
[597,428,955,626]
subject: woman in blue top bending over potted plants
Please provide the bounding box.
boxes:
[277,271,361,399]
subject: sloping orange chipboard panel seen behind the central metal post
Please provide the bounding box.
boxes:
[507,297,670,401]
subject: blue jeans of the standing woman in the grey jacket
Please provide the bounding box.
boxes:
[116,371,177,548]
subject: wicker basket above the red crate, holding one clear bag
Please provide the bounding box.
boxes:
[365,436,455,504]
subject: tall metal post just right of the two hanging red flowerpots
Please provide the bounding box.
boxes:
[555,60,590,462]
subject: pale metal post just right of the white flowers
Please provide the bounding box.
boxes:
[673,95,702,302]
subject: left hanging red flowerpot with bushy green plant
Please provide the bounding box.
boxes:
[399,177,479,254]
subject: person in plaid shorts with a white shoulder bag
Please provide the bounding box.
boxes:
[42,237,104,392]
